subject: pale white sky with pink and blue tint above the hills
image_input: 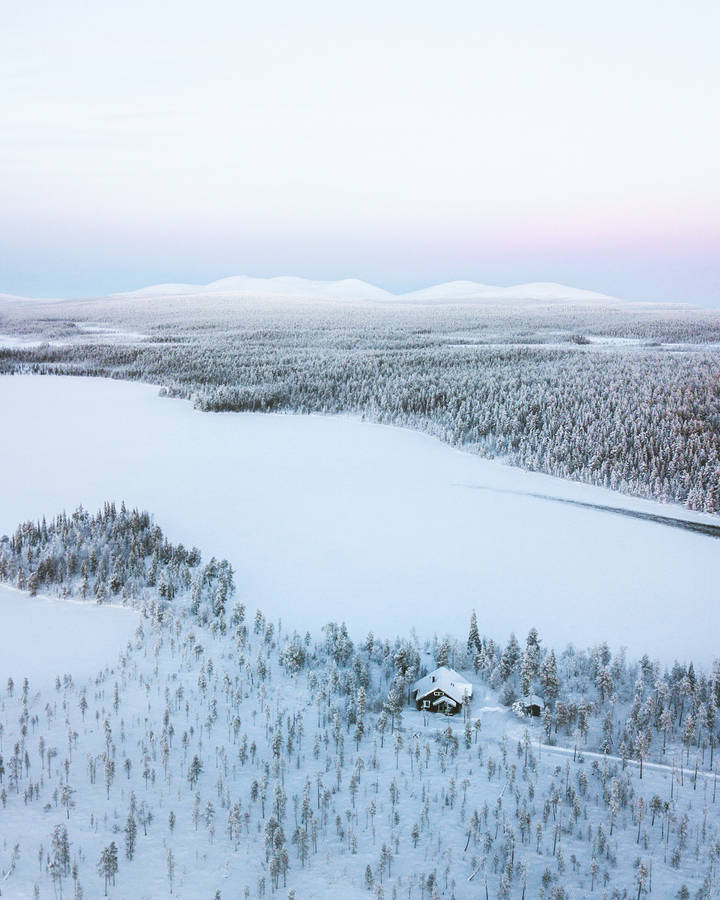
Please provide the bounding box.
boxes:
[0,0,720,307]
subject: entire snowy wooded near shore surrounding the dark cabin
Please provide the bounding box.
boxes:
[0,502,720,900]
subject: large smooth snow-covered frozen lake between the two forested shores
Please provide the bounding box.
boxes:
[0,376,720,666]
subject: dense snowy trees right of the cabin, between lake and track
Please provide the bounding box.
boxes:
[464,613,720,778]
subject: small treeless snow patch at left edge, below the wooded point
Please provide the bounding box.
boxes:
[0,585,139,689]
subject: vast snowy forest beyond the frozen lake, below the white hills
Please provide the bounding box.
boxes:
[0,298,720,513]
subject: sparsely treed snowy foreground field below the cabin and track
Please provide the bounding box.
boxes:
[0,572,719,900]
